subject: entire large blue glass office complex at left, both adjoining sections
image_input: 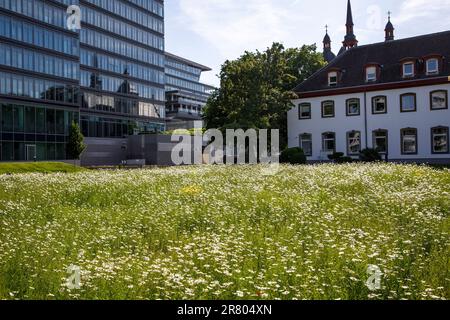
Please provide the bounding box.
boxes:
[0,0,165,161]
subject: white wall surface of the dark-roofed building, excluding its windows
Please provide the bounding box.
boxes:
[288,84,450,163]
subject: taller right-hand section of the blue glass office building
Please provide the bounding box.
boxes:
[80,0,165,138]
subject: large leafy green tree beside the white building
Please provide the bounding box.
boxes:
[204,43,325,148]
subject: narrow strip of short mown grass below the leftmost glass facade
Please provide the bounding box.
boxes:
[0,162,83,174]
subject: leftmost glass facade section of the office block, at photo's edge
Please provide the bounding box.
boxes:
[0,0,81,161]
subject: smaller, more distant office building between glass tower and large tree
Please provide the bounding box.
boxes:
[165,52,214,130]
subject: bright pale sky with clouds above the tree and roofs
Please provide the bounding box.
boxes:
[165,0,450,85]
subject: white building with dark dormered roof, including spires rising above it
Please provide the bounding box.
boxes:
[288,1,450,163]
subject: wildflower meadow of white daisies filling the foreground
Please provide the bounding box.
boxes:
[0,164,450,299]
